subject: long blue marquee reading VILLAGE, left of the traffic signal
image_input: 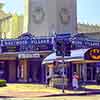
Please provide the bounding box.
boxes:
[0,34,53,52]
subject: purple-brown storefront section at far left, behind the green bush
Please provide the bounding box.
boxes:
[0,54,17,82]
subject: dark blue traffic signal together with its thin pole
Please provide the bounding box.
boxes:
[55,33,71,93]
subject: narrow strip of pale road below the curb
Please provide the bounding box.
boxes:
[0,95,100,100]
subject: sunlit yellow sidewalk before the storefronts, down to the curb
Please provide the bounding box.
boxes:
[0,84,100,98]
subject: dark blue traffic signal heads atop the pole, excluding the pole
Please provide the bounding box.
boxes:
[55,33,71,56]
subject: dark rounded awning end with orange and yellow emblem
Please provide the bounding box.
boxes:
[85,48,100,60]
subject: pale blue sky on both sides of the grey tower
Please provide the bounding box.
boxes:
[0,0,100,24]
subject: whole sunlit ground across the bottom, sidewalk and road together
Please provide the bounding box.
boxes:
[0,84,100,100]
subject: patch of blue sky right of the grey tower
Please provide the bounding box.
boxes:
[77,0,100,24]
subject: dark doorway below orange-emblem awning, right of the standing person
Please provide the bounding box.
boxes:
[87,63,96,82]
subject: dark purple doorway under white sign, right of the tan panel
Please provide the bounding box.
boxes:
[28,59,42,83]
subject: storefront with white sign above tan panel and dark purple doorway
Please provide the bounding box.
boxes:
[17,53,48,83]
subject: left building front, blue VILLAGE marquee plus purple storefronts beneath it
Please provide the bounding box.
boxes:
[0,34,53,83]
